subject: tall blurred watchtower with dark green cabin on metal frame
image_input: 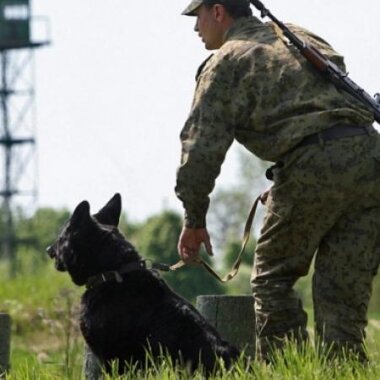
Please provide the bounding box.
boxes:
[0,0,50,274]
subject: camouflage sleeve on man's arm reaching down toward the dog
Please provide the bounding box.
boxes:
[175,57,235,228]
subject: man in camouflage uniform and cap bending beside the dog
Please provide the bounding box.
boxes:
[176,0,380,361]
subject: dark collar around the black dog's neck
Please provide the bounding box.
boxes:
[86,259,170,289]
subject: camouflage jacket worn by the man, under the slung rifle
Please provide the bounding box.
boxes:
[175,17,373,228]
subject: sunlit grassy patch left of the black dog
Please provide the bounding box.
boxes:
[0,250,83,379]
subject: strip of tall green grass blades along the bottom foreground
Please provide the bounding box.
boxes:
[8,346,380,380]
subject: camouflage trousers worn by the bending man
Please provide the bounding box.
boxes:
[251,130,380,360]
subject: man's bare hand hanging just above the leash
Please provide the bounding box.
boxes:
[178,227,212,263]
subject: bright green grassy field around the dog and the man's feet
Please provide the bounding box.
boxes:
[0,256,380,380]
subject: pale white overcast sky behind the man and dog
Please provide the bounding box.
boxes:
[8,0,380,221]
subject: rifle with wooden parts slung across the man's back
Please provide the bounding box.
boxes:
[250,0,380,124]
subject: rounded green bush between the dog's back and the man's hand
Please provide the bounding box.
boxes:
[131,211,223,301]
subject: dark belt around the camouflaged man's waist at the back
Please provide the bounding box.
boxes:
[292,125,368,150]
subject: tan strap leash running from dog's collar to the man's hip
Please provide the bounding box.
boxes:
[168,194,265,283]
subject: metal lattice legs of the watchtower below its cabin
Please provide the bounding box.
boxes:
[0,4,49,273]
